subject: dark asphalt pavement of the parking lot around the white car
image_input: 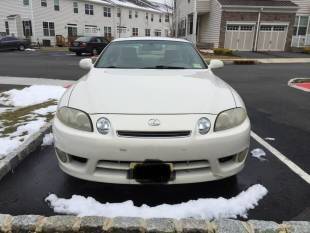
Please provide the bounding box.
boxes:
[0,53,310,221]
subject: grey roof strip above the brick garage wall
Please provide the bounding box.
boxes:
[218,0,298,7]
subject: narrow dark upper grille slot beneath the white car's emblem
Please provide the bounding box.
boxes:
[117,130,191,138]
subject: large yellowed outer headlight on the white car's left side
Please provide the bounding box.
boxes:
[57,107,93,132]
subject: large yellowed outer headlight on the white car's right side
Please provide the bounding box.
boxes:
[214,108,247,131]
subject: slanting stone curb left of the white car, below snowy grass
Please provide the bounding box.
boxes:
[0,123,52,180]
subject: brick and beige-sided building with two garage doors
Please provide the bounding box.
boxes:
[175,0,310,51]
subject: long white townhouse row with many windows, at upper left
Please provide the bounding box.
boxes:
[0,0,172,45]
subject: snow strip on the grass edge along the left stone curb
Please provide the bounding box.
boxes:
[0,118,46,157]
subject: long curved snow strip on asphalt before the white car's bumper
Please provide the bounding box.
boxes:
[45,184,268,220]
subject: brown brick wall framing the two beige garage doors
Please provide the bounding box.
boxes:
[219,11,296,50]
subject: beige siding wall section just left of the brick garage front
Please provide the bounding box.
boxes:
[199,0,222,48]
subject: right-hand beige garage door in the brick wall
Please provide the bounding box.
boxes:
[257,25,287,51]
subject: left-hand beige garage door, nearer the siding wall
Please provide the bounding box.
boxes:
[224,24,255,51]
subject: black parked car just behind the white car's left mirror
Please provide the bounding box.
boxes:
[69,36,110,56]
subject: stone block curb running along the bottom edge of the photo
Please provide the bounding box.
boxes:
[0,214,310,233]
